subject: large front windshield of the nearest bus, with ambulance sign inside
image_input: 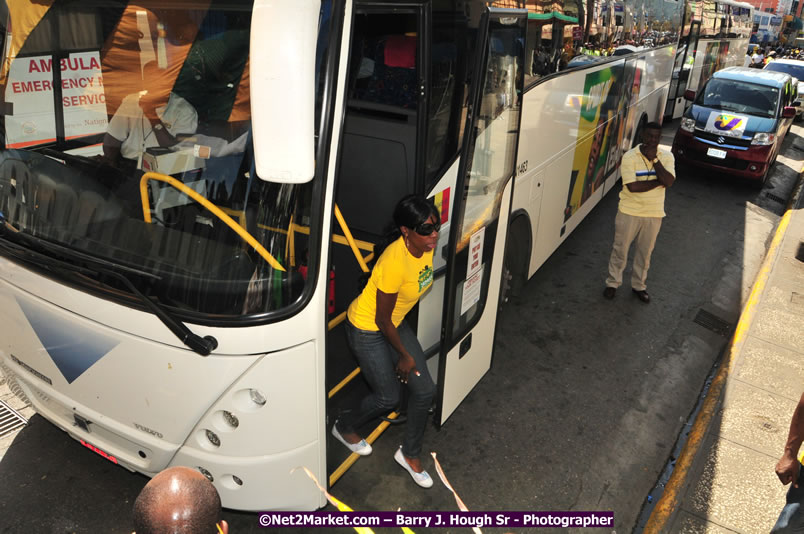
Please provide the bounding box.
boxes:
[0,0,331,320]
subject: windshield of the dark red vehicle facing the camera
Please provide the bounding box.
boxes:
[695,78,779,118]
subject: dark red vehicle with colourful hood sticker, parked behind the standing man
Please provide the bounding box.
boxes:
[673,67,798,185]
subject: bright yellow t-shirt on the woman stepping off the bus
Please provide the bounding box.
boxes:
[347,237,433,332]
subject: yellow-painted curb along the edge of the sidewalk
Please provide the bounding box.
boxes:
[642,175,804,534]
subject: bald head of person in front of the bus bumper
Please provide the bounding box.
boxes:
[134,467,225,534]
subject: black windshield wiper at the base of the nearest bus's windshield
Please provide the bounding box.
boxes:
[0,212,218,356]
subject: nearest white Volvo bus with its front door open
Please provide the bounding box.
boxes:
[0,0,681,510]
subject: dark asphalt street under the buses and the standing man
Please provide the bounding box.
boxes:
[0,122,804,534]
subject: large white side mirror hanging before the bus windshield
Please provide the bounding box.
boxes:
[249,0,321,184]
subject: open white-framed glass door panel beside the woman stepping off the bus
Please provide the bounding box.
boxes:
[435,8,527,426]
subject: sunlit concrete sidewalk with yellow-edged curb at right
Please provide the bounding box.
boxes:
[643,174,804,534]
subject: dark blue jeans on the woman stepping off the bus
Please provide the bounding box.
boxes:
[336,320,435,458]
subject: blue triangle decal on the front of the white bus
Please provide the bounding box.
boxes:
[17,299,120,384]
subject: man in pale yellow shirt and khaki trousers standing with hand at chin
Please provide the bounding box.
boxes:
[603,122,676,304]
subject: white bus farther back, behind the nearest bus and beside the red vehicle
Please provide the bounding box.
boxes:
[665,0,754,119]
